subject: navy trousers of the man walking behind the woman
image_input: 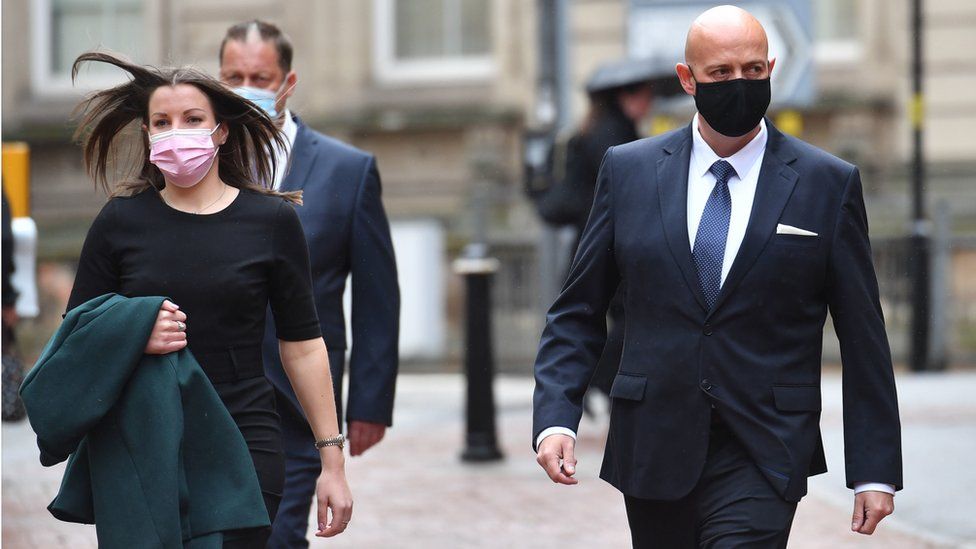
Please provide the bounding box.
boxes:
[267,351,346,549]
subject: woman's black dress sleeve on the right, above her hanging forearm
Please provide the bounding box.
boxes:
[269,202,322,341]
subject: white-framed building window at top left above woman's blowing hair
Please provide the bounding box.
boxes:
[31,0,147,95]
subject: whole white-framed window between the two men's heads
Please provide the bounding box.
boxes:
[374,0,494,82]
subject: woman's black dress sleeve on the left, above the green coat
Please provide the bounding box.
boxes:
[67,200,119,311]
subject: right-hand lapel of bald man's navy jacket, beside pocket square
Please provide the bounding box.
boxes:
[709,120,799,316]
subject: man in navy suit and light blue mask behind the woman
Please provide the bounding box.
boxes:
[220,20,400,548]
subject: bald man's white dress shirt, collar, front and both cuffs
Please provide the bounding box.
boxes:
[536,114,895,494]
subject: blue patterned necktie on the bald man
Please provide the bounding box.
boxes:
[692,160,735,310]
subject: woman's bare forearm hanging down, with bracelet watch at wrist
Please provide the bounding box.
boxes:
[278,338,344,470]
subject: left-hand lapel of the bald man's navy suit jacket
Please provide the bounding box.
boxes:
[657,124,708,311]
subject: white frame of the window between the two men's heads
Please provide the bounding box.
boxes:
[373,0,497,84]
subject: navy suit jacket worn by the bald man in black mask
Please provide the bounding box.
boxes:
[533,120,902,501]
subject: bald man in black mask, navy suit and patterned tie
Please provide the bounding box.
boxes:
[533,6,902,547]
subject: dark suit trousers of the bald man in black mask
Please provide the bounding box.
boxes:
[624,423,796,549]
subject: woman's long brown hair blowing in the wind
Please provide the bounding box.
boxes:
[71,52,302,204]
